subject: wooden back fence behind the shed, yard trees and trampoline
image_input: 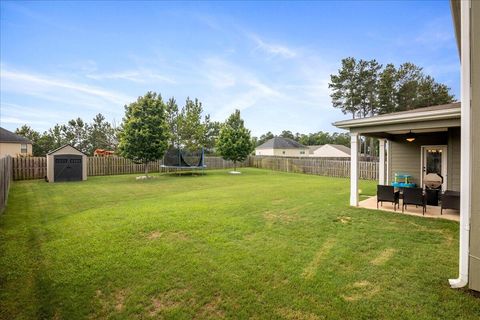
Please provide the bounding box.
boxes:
[10,157,248,180]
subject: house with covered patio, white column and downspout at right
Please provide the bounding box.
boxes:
[335,0,480,291]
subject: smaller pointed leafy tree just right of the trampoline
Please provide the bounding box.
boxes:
[217,110,254,170]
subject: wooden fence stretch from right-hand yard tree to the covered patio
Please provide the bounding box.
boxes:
[250,156,378,180]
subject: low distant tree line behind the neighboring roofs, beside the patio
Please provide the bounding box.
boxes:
[254,130,350,147]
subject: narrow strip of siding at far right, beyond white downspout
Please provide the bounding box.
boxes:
[469,1,480,291]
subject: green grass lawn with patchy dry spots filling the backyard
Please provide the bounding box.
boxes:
[0,169,480,319]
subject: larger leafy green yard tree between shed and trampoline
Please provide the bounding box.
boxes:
[119,92,170,176]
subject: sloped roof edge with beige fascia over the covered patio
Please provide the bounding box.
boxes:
[333,102,460,129]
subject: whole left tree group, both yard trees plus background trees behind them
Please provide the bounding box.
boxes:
[15,92,254,175]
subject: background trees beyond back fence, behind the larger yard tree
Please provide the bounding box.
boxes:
[15,93,220,157]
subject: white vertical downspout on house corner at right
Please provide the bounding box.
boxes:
[449,0,471,288]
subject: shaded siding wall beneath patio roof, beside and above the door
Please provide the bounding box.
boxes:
[389,132,448,186]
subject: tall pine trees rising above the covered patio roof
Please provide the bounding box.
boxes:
[328,57,455,119]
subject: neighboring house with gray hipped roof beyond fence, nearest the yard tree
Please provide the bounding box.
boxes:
[255,137,309,157]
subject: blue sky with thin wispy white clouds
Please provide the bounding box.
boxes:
[0,0,460,135]
